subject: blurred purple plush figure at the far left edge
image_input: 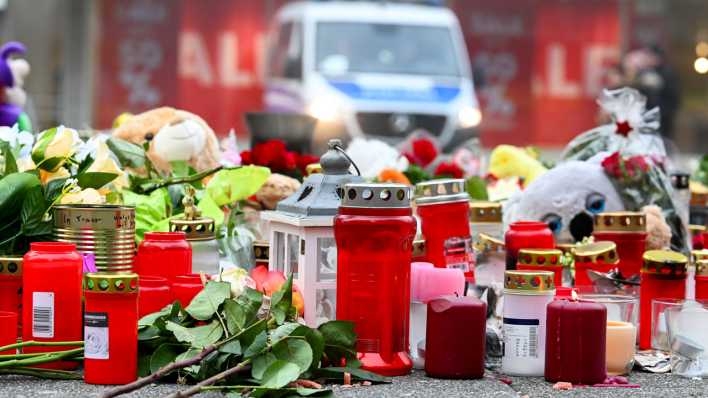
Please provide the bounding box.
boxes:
[0,41,32,132]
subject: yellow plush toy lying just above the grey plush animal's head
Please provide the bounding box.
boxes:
[489,145,548,188]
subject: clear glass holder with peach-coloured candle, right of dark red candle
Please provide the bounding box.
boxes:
[581,294,639,376]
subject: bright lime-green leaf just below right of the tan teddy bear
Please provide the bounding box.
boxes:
[207,166,270,206]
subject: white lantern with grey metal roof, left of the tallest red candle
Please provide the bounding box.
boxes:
[261,140,362,326]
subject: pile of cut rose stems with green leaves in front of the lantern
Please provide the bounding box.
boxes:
[138,277,387,397]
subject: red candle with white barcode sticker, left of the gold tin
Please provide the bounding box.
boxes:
[22,242,83,369]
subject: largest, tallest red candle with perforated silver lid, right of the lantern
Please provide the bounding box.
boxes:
[334,184,418,376]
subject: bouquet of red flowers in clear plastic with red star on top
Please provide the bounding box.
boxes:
[562,87,688,251]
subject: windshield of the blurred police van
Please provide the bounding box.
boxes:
[316,22,460,76]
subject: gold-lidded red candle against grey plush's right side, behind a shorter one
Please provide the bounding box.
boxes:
[592,211,647,279]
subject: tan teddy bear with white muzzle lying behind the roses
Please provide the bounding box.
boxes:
[113,107,221,173]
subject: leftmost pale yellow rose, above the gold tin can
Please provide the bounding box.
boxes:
[32,126,79,171]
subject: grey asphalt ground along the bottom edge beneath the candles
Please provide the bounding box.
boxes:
[0,372,708,398]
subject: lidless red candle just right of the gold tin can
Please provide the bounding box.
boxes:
[136,232,192,280]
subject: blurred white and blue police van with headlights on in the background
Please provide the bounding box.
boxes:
[264,1,482,152]
